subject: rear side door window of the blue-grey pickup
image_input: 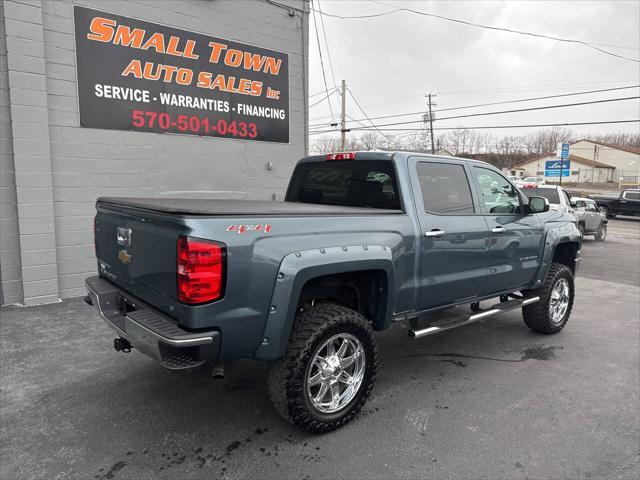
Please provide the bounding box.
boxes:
[416,162,475,215]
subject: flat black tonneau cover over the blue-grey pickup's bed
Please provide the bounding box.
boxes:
[97,197,403,216]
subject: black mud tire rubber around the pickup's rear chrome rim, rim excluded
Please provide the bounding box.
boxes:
[268,303,378,433]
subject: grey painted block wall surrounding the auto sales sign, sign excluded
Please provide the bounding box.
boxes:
[0,0,308,304]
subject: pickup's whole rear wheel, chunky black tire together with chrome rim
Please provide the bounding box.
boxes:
[268,303,378,433]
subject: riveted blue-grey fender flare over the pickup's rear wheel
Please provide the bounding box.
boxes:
[254,245,395,361]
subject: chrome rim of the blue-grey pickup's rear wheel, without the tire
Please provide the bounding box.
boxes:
[306,333,366,413]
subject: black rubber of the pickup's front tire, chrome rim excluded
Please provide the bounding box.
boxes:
[522,263,575,335]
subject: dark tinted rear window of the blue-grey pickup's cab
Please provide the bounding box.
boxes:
[285,160,400,210]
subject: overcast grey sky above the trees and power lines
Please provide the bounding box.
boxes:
[309,0,640,145]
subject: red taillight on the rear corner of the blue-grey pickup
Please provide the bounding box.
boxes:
[178,237,225,305]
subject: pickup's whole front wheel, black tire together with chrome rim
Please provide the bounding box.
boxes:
[522,263,575,335]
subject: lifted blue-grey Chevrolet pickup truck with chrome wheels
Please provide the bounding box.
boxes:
[86,152,582,432]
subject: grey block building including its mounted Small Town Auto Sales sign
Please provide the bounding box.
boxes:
[0,0,309,305]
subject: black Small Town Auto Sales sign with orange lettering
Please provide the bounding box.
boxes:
[74,6,289,143]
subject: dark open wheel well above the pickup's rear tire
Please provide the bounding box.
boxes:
[298,270,388,329]
